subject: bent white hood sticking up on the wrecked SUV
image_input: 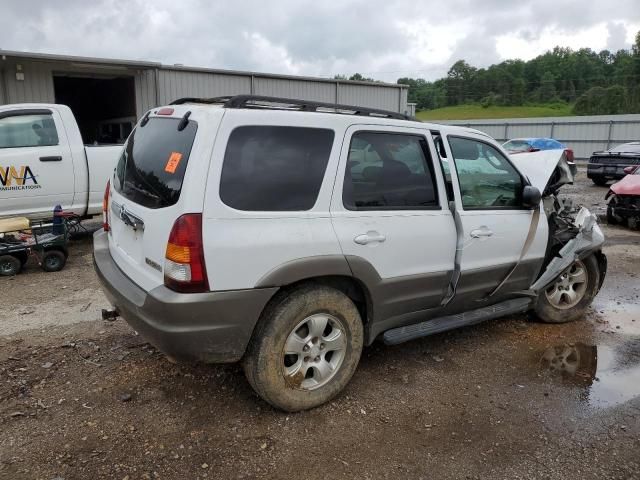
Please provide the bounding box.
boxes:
[509,150,573,194]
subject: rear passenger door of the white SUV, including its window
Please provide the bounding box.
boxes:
[331,125,456,331]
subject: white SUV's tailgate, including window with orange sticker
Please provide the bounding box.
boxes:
[109,105,219,290]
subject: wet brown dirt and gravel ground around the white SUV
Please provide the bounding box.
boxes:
[0,172,640,480]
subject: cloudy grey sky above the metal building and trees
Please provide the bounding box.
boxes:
[0,0,640,81]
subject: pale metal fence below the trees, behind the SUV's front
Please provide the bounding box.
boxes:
[437,115,640,159]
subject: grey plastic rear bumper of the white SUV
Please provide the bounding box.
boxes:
[93,230,277,363]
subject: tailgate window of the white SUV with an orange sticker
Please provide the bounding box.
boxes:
[114,118,198,208]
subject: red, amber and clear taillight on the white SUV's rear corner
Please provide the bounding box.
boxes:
[164,213,209,293]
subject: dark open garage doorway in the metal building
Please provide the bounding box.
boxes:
[53,74,136,144]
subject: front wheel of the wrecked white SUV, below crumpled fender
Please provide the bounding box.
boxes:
[535,255,600,323]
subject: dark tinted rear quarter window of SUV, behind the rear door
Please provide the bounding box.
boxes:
[220,126,334,211]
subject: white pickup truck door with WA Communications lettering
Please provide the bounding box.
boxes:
[0,108,75,216]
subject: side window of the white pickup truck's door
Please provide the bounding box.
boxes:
[0,114,58,148]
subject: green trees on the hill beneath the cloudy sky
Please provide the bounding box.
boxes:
[396,32,640,114]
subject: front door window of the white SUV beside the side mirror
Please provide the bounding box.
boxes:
[449,137,523,210]
